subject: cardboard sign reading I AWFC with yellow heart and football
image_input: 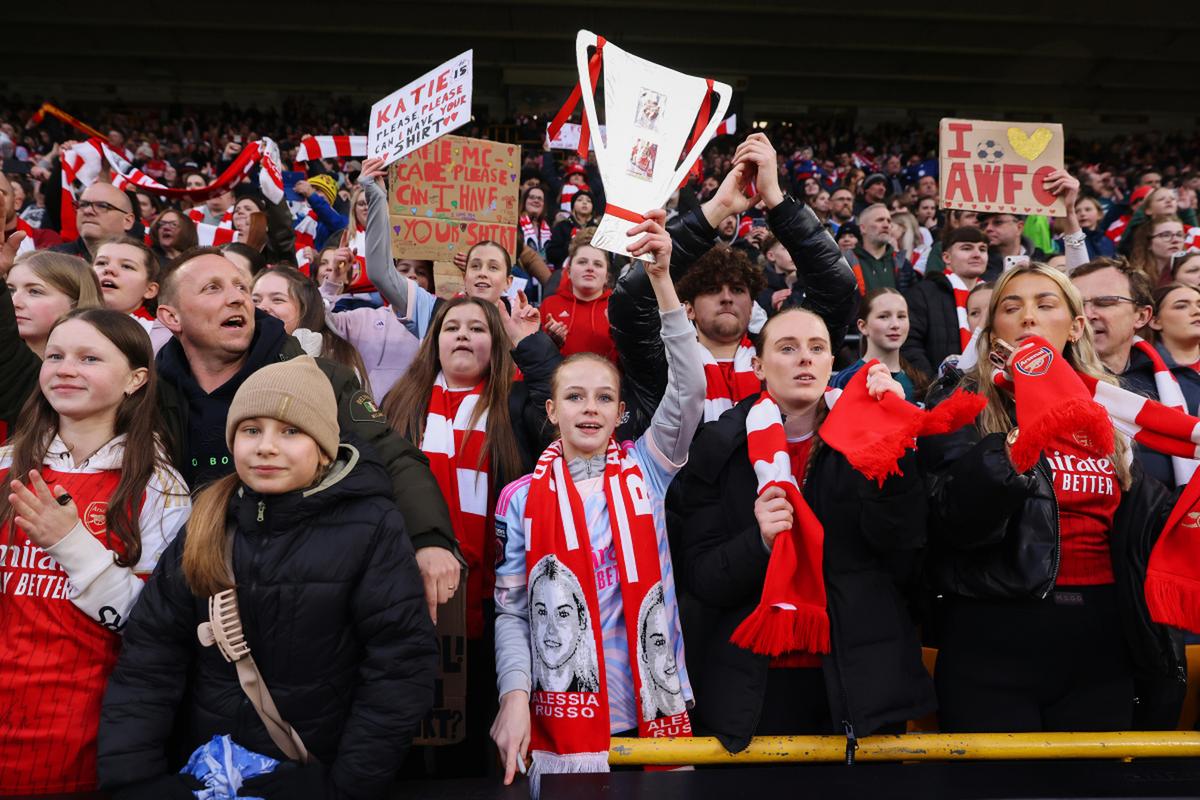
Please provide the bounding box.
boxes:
[938,119,1067,217]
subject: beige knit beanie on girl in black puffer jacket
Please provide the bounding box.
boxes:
[226,355,341,458]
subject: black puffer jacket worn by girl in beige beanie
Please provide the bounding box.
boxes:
[98,445,438,798]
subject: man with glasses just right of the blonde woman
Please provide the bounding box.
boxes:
[1070,258,1171,486]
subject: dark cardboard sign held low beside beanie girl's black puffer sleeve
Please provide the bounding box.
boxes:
[413,570,467,746]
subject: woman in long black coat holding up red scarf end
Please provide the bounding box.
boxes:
[679,308,980,757]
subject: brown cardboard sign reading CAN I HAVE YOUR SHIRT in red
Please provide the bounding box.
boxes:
[388,136,521,261]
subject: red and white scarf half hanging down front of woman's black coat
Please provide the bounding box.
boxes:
[730,393,830,656]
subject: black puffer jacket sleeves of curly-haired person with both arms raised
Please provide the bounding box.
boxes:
[608,197,857,438]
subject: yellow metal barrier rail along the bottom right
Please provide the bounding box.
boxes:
[608,730,1200,766]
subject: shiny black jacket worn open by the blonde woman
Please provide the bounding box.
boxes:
[918,384,1187,719]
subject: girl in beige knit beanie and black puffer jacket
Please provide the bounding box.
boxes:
[100,356,437,800]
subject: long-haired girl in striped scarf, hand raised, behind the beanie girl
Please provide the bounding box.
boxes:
[383,287,560,776]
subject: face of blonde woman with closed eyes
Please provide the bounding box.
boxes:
[991,273,1086,353]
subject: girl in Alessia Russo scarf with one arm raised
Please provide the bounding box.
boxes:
[492,210,704,796]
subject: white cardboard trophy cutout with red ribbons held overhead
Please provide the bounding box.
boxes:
[575,30,733,260]
